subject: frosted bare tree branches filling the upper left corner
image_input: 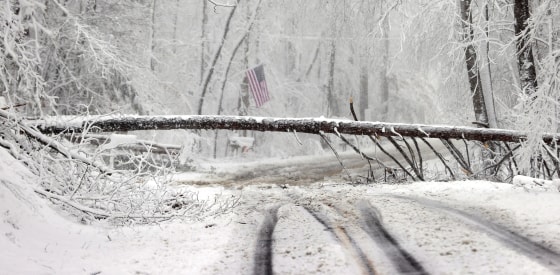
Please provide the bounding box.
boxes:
[0,0,143,115]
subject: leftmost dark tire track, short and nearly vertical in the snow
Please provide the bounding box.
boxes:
[253,205,281,275]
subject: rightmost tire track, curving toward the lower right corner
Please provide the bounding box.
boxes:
[390,195,560,274]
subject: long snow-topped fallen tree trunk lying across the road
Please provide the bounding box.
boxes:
[32,115,560,144]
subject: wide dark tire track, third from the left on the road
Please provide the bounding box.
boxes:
[357,200,429,274]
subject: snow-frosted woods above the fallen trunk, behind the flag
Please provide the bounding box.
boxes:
[1,0,559,136]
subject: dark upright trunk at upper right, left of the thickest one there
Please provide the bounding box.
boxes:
[460,0,488,127]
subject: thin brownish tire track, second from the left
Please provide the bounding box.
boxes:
[302,206,378,275]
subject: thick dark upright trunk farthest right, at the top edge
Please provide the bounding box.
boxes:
[513,0,537,95]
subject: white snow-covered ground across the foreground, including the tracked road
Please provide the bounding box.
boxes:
[0,150,560,274]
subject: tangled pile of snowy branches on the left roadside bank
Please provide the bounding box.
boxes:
[0,110,238,224]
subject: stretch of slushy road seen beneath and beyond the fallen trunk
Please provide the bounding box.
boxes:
[175,139,450,186]
